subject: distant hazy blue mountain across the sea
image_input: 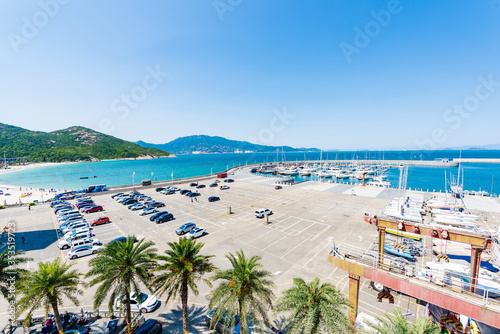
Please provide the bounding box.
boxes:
[136,135,319,153]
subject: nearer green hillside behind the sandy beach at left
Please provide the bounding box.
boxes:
[0,123,169,162]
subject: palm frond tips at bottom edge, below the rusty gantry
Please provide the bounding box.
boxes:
[366,310,441,334]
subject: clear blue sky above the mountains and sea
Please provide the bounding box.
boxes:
[0,0,500,149]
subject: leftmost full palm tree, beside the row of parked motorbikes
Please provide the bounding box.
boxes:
[17,258,84,334]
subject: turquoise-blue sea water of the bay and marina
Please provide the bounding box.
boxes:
[0,150,500,194]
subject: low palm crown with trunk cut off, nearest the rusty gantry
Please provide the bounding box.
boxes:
[274,278,352,334]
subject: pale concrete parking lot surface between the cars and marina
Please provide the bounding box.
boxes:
[0,172,432,333]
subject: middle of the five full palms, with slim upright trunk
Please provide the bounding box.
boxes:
[151,238,215,333]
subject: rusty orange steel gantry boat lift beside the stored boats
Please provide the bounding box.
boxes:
[328,214,500,327]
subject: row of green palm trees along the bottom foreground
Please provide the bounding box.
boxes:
[0,237,438,334]
